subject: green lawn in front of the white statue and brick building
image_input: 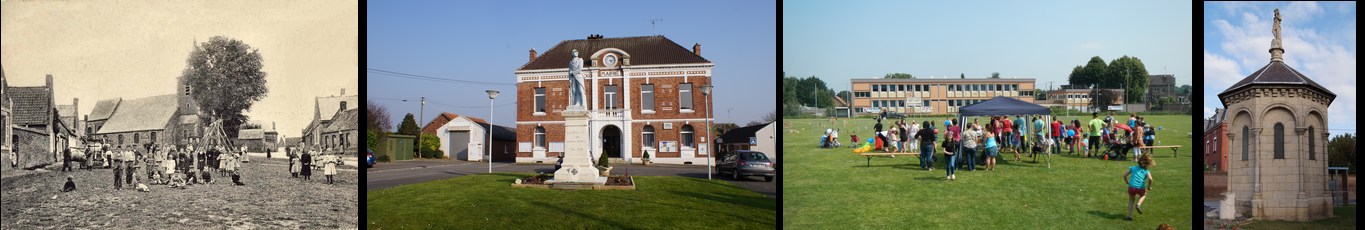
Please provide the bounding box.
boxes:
[366,174,777,229]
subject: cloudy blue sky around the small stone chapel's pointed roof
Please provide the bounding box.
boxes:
[1203,1,1357,136]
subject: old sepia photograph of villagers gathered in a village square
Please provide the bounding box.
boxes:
[0,1,362,229]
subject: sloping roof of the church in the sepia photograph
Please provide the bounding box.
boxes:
[97,94,177,134]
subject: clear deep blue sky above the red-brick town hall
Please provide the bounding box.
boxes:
[366,0,777,129]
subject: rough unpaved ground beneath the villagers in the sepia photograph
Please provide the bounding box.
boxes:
[0,159,359,229]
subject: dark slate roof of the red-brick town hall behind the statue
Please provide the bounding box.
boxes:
[517,36,711,70]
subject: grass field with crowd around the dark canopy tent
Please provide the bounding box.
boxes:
[782,116,1194,229]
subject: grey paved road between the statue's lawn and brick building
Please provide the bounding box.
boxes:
[364,160,778,197]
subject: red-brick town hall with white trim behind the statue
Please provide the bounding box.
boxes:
[516,36,714,164]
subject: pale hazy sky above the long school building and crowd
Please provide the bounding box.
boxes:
[782,0,1194,94]
